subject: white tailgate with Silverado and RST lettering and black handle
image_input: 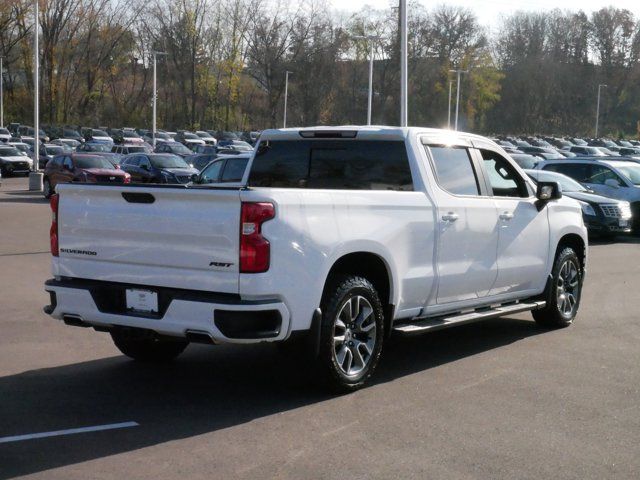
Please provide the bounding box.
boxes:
[54,184,240,293]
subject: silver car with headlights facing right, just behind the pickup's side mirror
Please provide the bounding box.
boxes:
[525,170,632,238]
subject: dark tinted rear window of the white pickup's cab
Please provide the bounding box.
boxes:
[249,140,413,191]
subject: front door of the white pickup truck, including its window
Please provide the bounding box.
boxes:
[480,149,550,296]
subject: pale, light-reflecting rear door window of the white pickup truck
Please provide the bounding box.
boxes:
[425,146,480,196]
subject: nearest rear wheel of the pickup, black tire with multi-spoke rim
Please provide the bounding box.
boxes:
[318,275,384,392]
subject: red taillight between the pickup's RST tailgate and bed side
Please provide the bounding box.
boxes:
[240,202,276,273]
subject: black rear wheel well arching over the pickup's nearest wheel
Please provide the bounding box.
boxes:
[322,252,394,334]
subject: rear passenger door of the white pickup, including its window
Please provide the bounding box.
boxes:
[425,141,498,305]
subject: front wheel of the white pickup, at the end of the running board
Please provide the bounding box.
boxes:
[531,247,582,328]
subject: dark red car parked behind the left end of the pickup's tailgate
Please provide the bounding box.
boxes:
[42,153,131,198]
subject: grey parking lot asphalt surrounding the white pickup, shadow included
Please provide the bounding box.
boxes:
[0,178,640,480]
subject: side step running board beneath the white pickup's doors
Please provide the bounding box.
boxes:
[393,301,546,335]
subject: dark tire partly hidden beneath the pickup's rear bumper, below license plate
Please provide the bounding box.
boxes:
[111,330,189,362]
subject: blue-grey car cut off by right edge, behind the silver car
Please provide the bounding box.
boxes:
[536,159,640,233]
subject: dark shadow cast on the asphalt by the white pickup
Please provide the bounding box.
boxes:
[0,319,545,479]
